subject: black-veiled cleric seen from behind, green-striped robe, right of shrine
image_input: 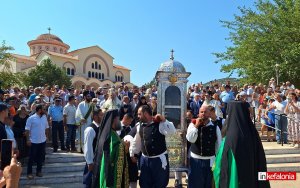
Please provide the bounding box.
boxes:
[213,101,270,188]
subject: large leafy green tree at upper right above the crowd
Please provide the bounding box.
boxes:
[214,0,300,86]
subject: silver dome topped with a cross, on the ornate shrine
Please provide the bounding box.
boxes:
[158,50,186,73]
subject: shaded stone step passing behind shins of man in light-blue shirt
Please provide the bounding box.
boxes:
[22,162,85,176]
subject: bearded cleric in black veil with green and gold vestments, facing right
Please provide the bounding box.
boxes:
[92,109,129,188]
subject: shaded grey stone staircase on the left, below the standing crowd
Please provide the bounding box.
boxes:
[20,147,85,188]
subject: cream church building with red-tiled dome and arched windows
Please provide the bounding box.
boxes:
[12,29,133,88]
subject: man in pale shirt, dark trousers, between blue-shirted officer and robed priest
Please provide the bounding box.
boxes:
[63,95,77,152]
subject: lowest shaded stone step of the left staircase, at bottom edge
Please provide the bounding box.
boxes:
[20,171,83,185]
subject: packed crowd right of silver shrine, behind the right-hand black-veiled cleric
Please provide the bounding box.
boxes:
[187,78,300,148]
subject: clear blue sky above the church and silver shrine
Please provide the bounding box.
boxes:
[0,0,254,85]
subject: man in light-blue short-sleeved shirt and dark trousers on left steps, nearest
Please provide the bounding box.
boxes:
[25,105,49,179]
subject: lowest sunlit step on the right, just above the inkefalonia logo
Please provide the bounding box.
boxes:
[267,163,300,172]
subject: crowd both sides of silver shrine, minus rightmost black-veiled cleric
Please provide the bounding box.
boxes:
[0,78,300,188]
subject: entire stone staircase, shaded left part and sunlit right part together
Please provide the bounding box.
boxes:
[20,124,300,188]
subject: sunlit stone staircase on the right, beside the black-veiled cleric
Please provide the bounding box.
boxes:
[256,124,300,172]
